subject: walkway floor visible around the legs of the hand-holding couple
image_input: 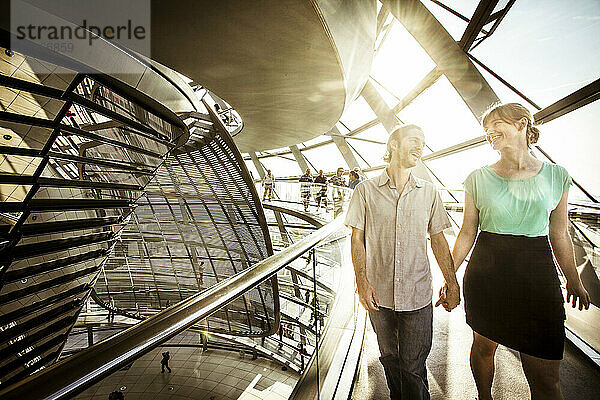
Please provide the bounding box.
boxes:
[352,290,600,400]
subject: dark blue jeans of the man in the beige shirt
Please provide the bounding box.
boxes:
[369,303,433,400]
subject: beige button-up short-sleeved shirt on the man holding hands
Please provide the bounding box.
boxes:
[344,170,451,311]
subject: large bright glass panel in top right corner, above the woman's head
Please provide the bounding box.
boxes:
[473,0,600,107]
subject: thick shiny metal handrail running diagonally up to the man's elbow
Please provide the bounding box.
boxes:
[0,213,344,400]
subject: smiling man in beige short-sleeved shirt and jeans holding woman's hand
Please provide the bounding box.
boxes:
[345,125,460,399]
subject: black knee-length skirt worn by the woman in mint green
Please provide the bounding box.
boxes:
[463,231,565,360]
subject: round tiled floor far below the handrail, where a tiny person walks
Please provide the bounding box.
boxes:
[75,346,299,400]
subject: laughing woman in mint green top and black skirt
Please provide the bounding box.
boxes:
[452,103,590,400]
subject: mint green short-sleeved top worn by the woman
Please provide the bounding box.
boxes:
[464,163,573,237]
